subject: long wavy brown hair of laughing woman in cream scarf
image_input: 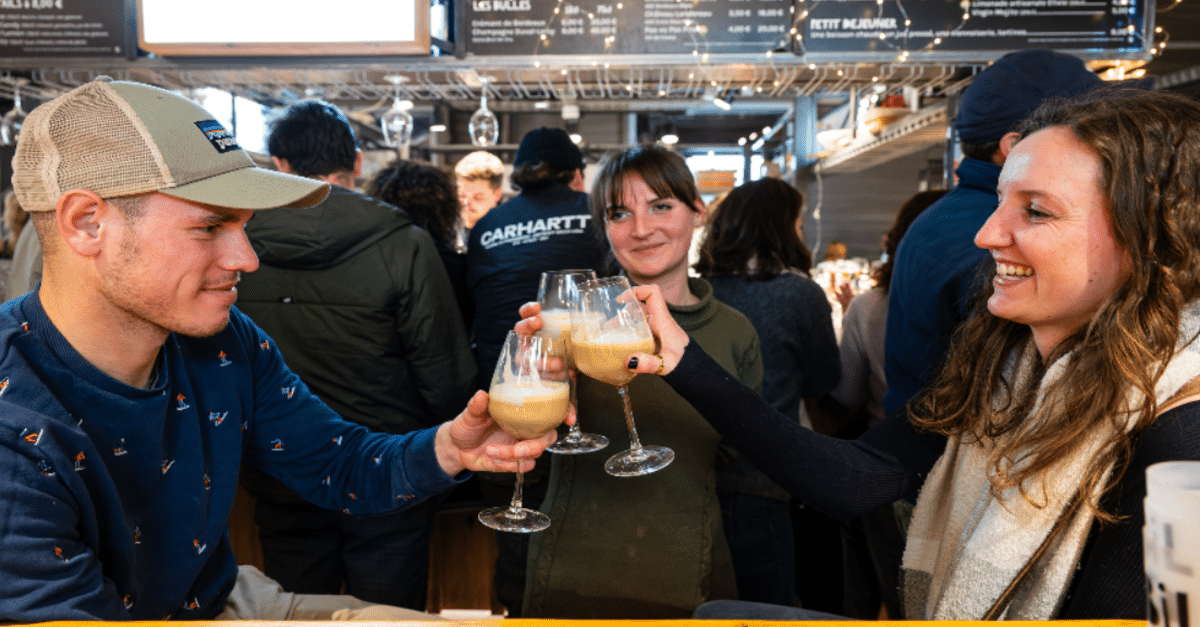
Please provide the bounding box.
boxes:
[910,90,1200,521]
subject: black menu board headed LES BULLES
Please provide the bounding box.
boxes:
[457,0,792,55]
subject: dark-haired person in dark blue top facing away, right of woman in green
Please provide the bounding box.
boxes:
[695,178,840,609]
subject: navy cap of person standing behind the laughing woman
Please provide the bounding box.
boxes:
[954,49,1104,144]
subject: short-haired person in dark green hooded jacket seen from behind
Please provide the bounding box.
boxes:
[239,100,475,609]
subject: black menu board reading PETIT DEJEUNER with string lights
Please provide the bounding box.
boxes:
[797,0,1153,53]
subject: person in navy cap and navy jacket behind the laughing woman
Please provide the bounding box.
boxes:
[883,49,1103,414]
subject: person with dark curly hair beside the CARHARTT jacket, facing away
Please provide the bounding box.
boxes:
[366,159,475,333]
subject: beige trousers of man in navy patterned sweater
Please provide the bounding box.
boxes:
[216,566,444,621]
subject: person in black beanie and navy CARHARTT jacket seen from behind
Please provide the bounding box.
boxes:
[467,127,608,616]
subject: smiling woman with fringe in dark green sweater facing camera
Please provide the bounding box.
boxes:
[523,148,762,619]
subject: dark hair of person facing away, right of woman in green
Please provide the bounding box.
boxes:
[696,178,812,280]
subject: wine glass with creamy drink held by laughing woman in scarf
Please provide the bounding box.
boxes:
[571,276,674,477]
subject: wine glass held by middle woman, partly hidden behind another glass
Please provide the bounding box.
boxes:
[538,270,608,455]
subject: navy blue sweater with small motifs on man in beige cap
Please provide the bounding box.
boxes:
[0,291,455,622]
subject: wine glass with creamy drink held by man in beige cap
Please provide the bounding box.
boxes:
[479,330,570,533]
